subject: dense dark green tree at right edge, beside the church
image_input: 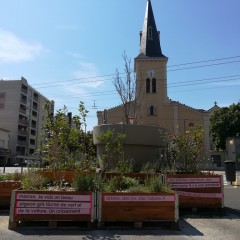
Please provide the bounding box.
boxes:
[210,102,240,150]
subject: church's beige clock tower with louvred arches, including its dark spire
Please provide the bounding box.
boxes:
[134,0,168,115]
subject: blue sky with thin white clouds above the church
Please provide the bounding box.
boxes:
[0,0,240,130]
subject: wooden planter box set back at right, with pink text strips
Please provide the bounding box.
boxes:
[166,174,224,208]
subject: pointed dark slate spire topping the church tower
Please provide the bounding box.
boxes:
[137,0,165,58]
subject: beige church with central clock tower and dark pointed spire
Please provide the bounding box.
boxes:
[97,0,210,157]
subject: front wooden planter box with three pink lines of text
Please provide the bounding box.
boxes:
[9,190,94,229]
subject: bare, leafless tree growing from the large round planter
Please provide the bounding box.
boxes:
[113,52,141,124]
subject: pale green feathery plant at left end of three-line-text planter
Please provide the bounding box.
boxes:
[21,169,48,190]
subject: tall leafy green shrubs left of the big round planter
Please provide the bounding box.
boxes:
[38,102,96,171]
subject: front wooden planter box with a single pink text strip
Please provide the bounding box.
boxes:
[98,192,179,229]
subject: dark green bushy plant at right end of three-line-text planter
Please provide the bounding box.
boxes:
[72,174,96,192]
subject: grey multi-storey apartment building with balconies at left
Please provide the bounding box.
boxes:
[0,77,54,164]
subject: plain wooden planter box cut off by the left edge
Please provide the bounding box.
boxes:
[0,181,21,207]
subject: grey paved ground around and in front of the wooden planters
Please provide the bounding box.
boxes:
[0,172,240,240]
